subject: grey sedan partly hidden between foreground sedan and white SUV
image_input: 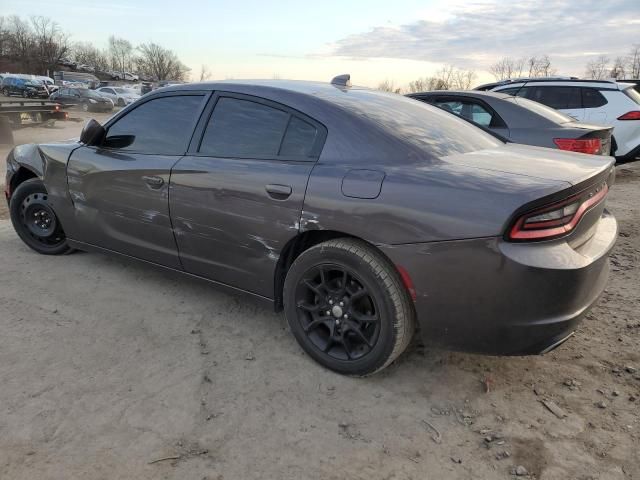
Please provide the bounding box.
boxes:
[407,91,613,155]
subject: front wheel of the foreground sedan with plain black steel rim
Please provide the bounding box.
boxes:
[9,178,72,255]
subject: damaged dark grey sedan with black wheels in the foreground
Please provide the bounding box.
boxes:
[6,77,617,375]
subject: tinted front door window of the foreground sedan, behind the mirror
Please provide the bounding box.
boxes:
[108,95,203,155]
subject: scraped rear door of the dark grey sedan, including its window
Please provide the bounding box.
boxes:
[169,95,326,298]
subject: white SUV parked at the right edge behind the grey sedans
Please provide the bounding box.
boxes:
[477,78,640,161]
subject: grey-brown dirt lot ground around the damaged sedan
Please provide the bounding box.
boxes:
[0,117,640,480]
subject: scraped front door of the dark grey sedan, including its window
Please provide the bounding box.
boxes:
[67,93,205,268]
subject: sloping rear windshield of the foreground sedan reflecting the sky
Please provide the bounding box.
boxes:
[324,89,503,157]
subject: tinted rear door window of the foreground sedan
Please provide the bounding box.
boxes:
[200,97,289,157]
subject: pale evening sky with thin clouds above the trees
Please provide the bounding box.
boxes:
[0,0,640,87]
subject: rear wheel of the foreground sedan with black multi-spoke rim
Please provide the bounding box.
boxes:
[283,238,416,376]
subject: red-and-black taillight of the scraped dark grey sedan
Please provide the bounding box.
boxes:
[509,183,609,241]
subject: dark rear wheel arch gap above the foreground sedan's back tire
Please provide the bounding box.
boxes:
[273,230,413,312]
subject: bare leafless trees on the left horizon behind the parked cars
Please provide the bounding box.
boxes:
[0,15,189,80]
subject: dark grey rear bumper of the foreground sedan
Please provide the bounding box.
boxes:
[382,211,618,355]
